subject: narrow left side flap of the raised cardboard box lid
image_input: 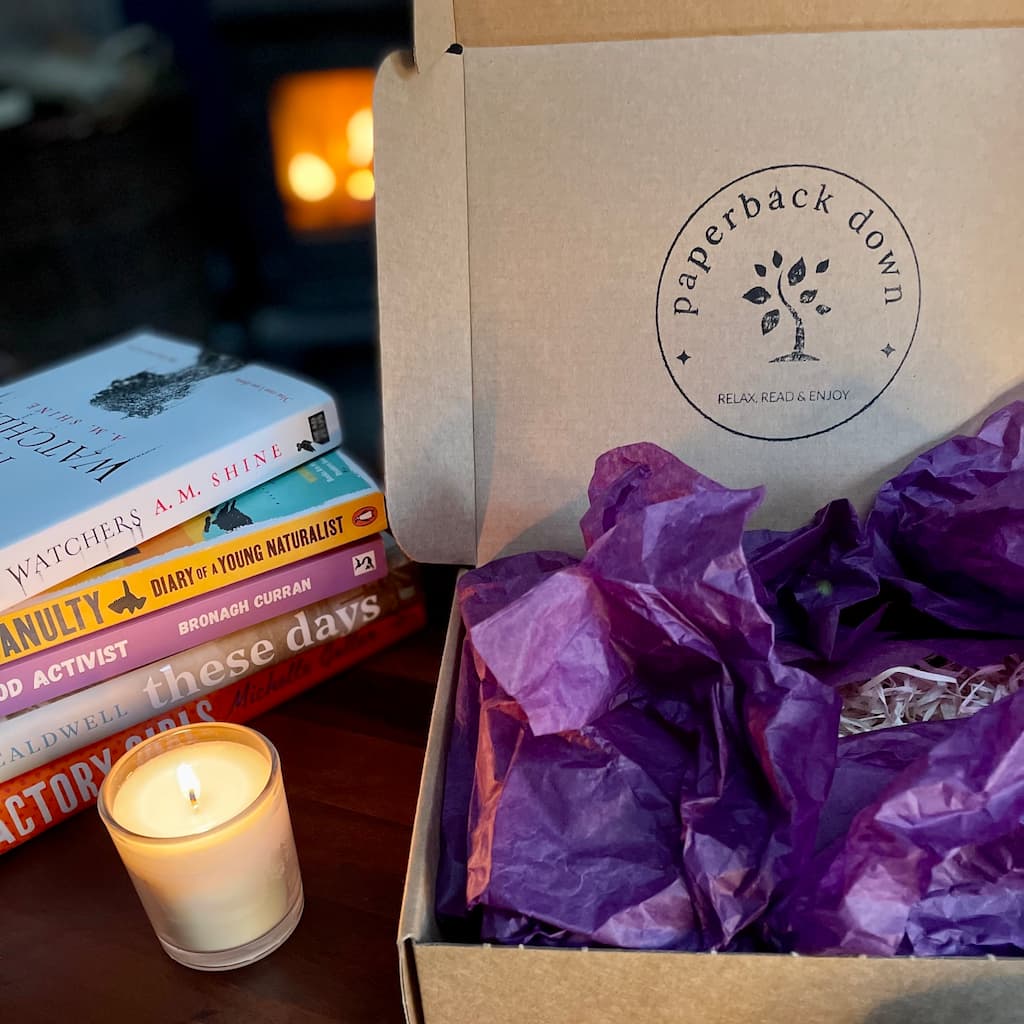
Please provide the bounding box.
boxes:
[374,54,476,564]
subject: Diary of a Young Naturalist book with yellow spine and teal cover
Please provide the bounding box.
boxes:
[0,449,387,663]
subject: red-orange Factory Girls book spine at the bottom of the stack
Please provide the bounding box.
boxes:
[0,601,426,853]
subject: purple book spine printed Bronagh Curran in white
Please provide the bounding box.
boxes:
[0,535,387,722]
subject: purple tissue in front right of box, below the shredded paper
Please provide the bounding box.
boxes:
[768,690,1024,956]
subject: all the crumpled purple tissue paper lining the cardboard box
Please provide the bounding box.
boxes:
[437,402,1024,956]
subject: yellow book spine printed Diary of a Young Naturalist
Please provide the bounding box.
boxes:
[0,489,387,666]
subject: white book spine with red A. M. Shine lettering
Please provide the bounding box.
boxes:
[0,395,341,608]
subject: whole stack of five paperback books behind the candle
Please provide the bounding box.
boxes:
[0,334,426,853]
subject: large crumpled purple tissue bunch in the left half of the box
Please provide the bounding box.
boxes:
[442,444,839,949]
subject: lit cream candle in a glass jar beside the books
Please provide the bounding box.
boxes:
[98,723,302,971]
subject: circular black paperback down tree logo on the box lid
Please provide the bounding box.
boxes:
[657,164,921,441]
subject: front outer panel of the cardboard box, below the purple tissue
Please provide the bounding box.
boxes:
[413,942,1024,1024]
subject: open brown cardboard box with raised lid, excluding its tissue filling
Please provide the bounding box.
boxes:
[375,0,1024,1024]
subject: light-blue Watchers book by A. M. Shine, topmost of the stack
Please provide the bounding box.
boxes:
[0,333,341,608]
